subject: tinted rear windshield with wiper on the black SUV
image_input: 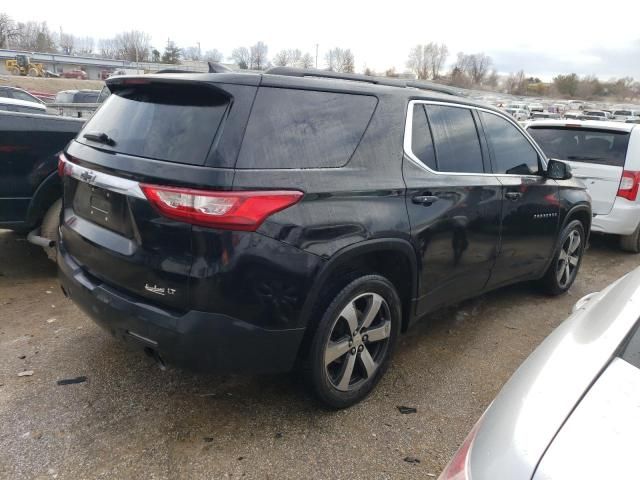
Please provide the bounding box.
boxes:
[78,83,229,165]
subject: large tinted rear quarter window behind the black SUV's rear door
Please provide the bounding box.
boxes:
[237,87,377,168]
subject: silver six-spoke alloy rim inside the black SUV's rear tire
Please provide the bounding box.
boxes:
[324,292,391,392]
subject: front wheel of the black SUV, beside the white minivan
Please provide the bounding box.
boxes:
[542,220,586,295]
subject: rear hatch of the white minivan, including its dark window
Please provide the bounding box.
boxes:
[528,125,630,215]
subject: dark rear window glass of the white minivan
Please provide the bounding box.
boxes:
[527,127,629,167]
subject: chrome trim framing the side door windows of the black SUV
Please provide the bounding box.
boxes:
[403,100,547,178]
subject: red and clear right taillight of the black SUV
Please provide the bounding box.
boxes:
[140,184,302,231]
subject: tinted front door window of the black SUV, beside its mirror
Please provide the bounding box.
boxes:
[480,112,540,175]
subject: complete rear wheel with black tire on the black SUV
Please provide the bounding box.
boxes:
[307,275,402,408]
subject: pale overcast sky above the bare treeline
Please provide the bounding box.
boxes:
[5,0,640,79]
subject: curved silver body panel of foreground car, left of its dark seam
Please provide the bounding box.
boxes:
[469,269,640,480]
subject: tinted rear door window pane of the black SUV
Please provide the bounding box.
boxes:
[426,105,484,173]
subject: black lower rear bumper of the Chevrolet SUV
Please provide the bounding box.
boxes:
[58,249,305,373]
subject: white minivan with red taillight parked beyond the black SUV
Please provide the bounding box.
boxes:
[526,120,640,253]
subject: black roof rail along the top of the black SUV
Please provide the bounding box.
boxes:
[264,67,463,95]
